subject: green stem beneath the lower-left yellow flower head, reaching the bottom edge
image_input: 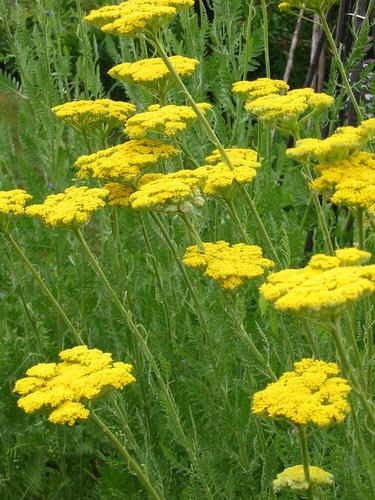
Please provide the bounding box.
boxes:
[90,411,165,500]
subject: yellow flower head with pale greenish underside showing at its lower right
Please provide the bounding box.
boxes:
[130,170,204,213]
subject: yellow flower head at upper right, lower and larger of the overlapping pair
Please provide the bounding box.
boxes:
[245,88,334,128]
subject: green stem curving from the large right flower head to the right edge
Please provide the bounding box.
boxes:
[332,319,375,431]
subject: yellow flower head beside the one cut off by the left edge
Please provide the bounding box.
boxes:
[26,186,108,227]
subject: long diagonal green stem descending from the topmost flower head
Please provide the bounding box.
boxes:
[148,33,280,263]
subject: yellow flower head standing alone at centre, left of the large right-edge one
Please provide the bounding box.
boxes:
[183,241,275,290]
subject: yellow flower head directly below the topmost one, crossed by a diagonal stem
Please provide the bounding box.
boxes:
[108,56,199,86]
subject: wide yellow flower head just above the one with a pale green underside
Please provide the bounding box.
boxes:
[74,139,180,183]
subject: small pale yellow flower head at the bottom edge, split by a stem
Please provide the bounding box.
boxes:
[272,465,334,493]
